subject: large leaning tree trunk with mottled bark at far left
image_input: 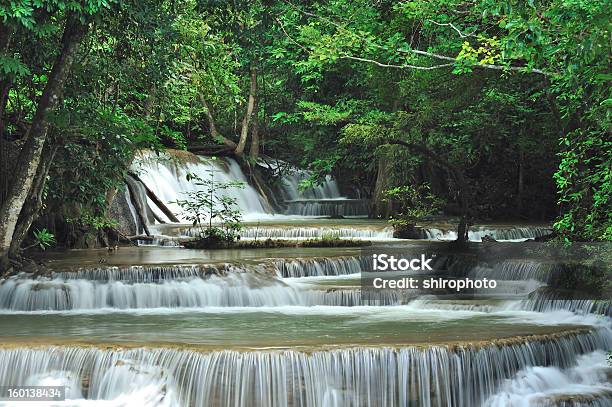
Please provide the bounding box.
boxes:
[0,16,87,270]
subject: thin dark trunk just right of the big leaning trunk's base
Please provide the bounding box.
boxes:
[9,142,59,258]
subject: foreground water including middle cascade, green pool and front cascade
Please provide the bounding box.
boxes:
[0,248,612,406]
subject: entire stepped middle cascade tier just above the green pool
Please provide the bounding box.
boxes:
[0,256,612,316]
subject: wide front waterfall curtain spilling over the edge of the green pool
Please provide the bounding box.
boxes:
[0,330,612,407]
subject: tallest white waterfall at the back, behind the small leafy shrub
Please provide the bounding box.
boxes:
[132,150,269,222]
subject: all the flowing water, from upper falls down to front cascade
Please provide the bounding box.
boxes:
[0,152,612,407]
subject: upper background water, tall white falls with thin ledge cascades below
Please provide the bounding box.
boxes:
[128,150,551,245]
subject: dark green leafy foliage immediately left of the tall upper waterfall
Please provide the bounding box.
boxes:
[49,103,162,217]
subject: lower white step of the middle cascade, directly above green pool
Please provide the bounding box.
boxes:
[0,273,390,311]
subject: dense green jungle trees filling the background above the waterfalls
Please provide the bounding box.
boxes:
[0,0,612,269]
